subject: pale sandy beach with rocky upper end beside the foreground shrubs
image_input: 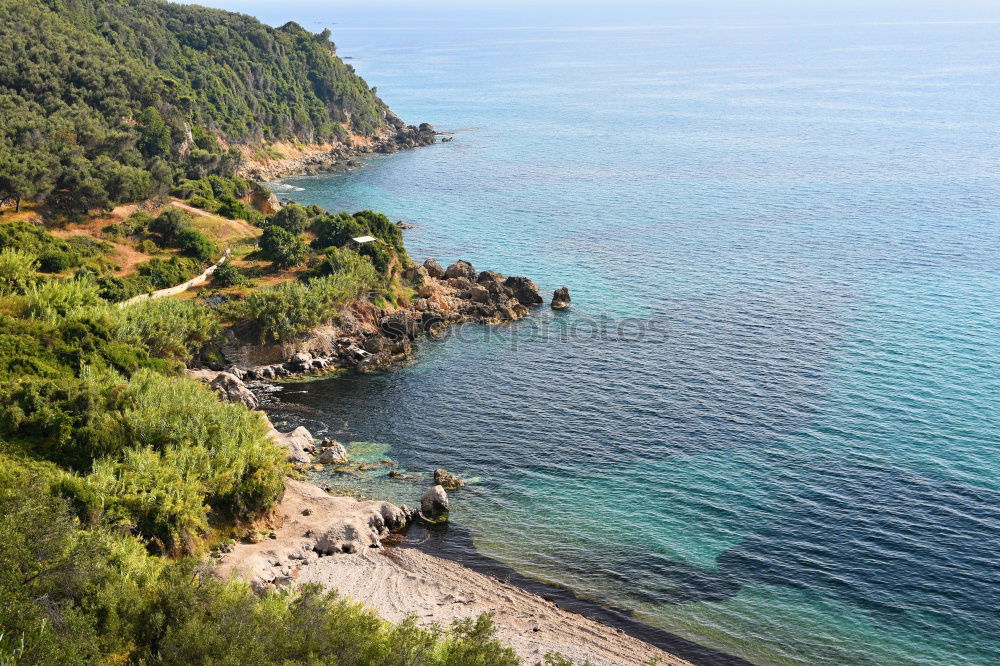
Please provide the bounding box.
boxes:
[217,479,689,666]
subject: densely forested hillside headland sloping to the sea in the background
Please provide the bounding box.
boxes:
[0,0,426,214]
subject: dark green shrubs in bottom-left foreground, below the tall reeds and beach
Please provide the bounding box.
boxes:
[0,456,519,666]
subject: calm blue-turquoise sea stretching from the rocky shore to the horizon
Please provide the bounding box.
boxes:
[207,2,1000,664]
